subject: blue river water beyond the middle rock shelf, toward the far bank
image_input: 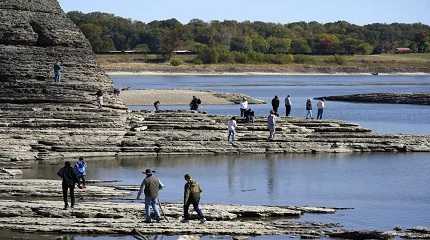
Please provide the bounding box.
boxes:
[113,76,430,134]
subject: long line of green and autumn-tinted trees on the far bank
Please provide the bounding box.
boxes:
[68,12,430,63]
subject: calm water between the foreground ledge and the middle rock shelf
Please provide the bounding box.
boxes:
[24,153,430,230]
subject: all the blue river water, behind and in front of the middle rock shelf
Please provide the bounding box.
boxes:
[16,76,430,240]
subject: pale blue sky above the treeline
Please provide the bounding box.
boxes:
[60,0,430,25]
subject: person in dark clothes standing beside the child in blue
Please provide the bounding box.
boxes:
[57,161,81,210]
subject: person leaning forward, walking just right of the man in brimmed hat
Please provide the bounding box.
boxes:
[182,174,206,223]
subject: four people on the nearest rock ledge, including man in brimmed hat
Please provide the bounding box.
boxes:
[57,157,206,223]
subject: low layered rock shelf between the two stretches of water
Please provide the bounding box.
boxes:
[120,111,430,155]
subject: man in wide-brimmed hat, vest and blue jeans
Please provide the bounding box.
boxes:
[137,169,164,223]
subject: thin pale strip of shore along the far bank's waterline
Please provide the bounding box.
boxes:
[106,71,430,76]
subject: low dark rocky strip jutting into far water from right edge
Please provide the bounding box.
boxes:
[317,93,430,105]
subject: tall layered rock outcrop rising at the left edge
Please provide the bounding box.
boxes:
[0,0,127,167]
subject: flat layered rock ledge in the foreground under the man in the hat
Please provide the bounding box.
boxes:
[0,180,430,239]
